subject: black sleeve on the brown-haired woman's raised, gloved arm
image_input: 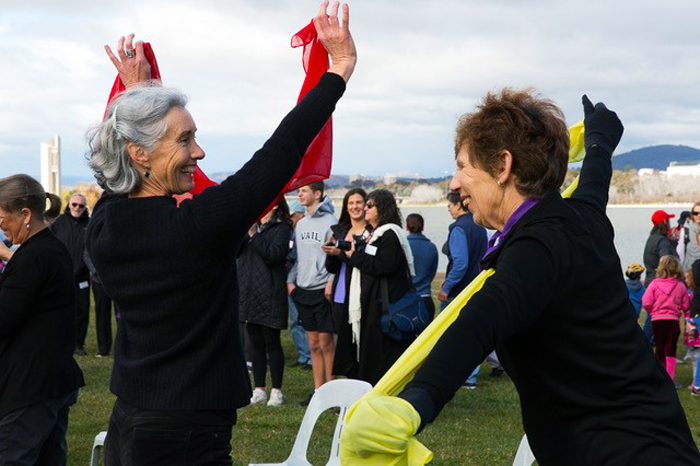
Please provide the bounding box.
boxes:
[571,146,612,213]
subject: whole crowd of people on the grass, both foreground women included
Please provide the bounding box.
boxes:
[0,2,700,466]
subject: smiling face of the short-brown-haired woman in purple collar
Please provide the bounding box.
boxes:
[450,146,505,229]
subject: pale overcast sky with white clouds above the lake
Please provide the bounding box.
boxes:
[0,0,700,179]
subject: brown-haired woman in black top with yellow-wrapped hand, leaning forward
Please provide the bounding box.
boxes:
[341,89,700,465]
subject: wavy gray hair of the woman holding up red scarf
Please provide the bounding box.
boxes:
[86,86,187,193]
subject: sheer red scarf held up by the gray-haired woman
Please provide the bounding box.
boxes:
[105,22,333,209]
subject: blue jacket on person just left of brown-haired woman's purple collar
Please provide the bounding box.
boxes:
[442,212,488,298]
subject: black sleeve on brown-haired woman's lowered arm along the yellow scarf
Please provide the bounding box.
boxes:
[399,236,566,426]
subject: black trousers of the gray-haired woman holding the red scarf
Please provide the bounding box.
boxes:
[104,399,233,466]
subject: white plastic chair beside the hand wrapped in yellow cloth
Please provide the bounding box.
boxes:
[249,379,372,466]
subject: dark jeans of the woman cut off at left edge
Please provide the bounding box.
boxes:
[0,390,78,466]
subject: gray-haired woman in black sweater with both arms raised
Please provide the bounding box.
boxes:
[86,2,356,466]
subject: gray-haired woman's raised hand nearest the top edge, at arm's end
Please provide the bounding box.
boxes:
[313,0,357,82]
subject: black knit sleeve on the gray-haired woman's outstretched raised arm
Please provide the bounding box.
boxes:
[180,73,345,238]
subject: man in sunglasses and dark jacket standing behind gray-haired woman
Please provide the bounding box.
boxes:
[51,193,90,356]
